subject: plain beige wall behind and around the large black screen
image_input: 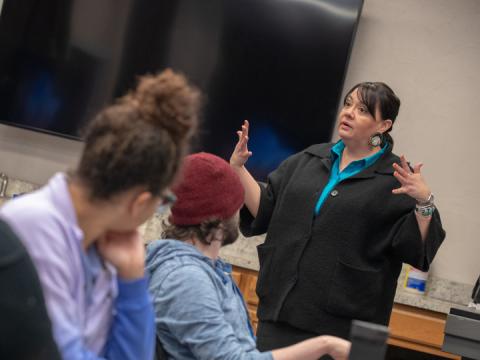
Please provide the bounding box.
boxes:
[0,0,480,283]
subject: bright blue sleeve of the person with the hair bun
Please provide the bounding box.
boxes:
[105,277,155,360]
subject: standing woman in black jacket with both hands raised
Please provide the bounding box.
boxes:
[230,82,445,351]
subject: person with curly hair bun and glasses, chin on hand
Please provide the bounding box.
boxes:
[0,70,200,359]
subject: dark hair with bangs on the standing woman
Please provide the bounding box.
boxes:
[343,82,400,145]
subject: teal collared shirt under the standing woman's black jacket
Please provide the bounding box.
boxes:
[315,140,388,215]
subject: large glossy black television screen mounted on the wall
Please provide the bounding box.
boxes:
[0,0,363,179]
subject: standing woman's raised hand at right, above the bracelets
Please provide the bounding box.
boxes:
[392,155,430,202]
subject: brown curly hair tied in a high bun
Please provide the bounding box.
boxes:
[74,69,200,200]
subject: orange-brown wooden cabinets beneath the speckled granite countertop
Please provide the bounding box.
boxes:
[232,266,460,359]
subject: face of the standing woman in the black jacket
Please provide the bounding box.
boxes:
[338,89,391,145]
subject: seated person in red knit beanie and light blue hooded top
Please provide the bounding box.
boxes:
[147,153,350,360]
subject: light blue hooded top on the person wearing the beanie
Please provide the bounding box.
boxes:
[147,240,272,360]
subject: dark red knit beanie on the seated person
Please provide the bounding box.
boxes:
[169,153,245,226]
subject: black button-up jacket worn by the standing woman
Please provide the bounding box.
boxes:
[240,144,445,338]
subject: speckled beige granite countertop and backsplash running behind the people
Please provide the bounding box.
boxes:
[0,180,473,314]
